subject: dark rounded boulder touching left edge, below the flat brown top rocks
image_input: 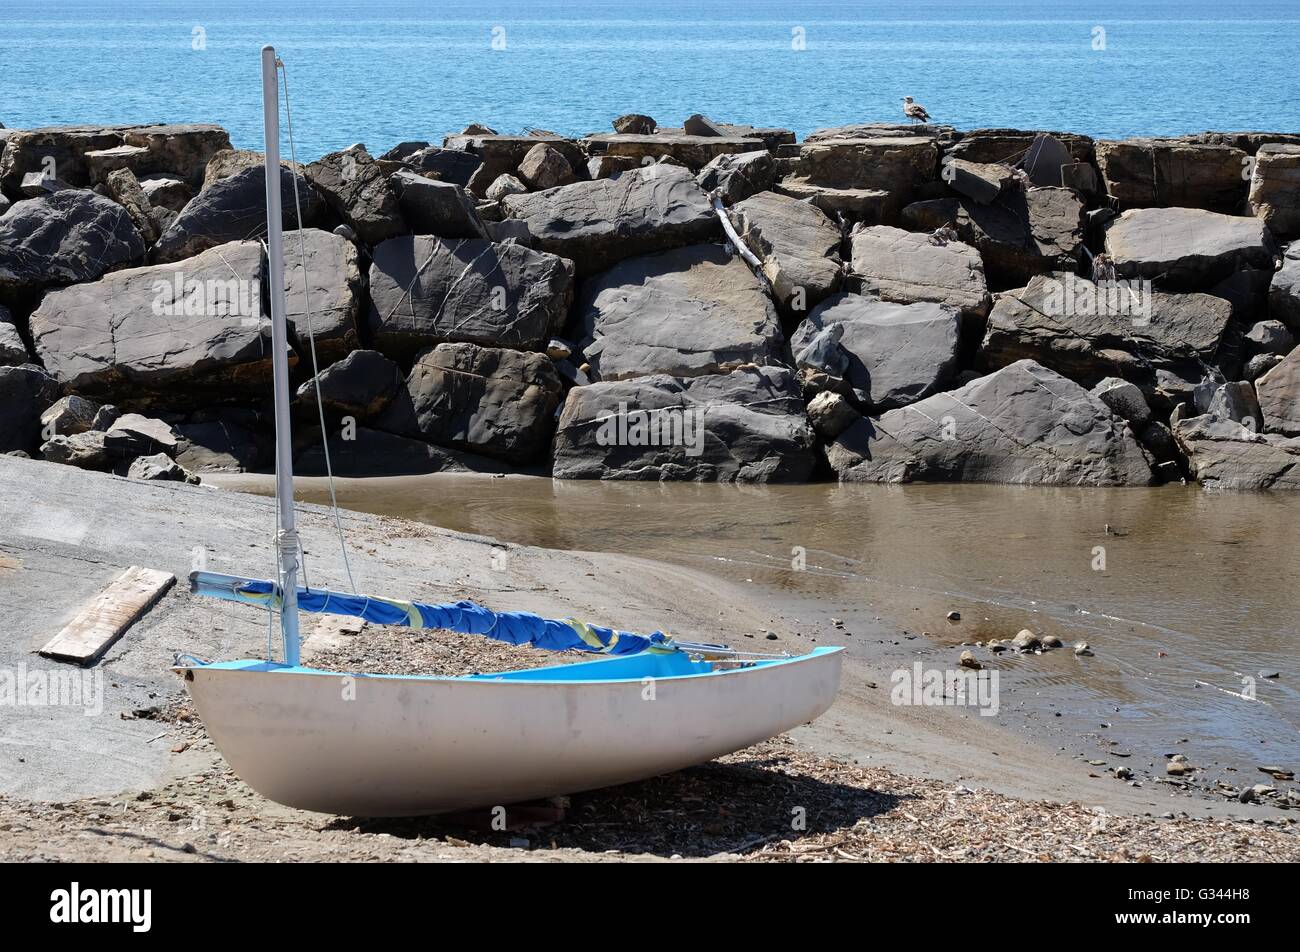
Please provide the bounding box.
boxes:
[0,189,144,290]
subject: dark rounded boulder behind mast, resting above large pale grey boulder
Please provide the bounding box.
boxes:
[153,166,325,261]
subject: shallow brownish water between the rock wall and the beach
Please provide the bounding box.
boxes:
[220,476,1300,783]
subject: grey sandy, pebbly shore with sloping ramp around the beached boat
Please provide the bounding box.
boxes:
[0,459,1300,861]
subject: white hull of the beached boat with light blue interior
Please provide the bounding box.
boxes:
[178,649,841,817]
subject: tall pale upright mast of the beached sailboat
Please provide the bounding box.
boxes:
[261,46,299,665]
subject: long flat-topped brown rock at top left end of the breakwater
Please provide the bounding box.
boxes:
[0,125,230,191]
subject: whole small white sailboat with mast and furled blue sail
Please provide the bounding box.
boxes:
[173,46,844,817]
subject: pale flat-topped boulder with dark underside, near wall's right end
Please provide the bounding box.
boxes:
[1106,208,1277,289]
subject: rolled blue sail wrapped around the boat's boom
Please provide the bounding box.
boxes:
[190,572,676,654]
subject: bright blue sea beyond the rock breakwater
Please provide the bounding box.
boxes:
[0,0,1300,159]
